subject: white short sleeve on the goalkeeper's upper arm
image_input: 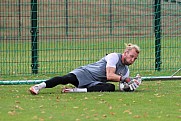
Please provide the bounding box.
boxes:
[105,53,119,68]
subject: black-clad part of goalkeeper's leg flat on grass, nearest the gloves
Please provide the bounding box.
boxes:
[87,83,115,92]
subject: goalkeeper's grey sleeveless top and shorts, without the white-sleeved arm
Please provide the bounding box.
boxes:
[70,53,129,88]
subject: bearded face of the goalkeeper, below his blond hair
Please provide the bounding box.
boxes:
[122,49,138,66]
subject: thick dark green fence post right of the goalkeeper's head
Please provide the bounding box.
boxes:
[154,0,161,71]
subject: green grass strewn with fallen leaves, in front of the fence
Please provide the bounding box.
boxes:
[0,81,181,121]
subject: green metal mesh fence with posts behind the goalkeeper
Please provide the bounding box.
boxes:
[0,0,181,77]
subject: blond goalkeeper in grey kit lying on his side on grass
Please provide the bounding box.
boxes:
[29,43,141,95]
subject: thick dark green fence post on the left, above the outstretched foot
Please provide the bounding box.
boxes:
[31,0,38,74]
